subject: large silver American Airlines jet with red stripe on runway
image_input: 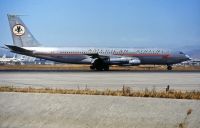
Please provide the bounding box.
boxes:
[6,14,190,71]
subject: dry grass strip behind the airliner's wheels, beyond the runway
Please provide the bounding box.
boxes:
[0,64,200,71]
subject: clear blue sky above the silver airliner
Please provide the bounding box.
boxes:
[0,0,200,48]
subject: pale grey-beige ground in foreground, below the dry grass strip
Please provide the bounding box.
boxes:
[0,92,200,128]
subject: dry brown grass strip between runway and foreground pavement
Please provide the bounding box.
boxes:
[0,86,200,100]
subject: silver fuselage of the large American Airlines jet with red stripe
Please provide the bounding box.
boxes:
[15,47,189,65]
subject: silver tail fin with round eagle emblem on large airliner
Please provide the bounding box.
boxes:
[8,14,40,47]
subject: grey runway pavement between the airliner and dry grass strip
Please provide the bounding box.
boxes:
[0,71,200,90]
